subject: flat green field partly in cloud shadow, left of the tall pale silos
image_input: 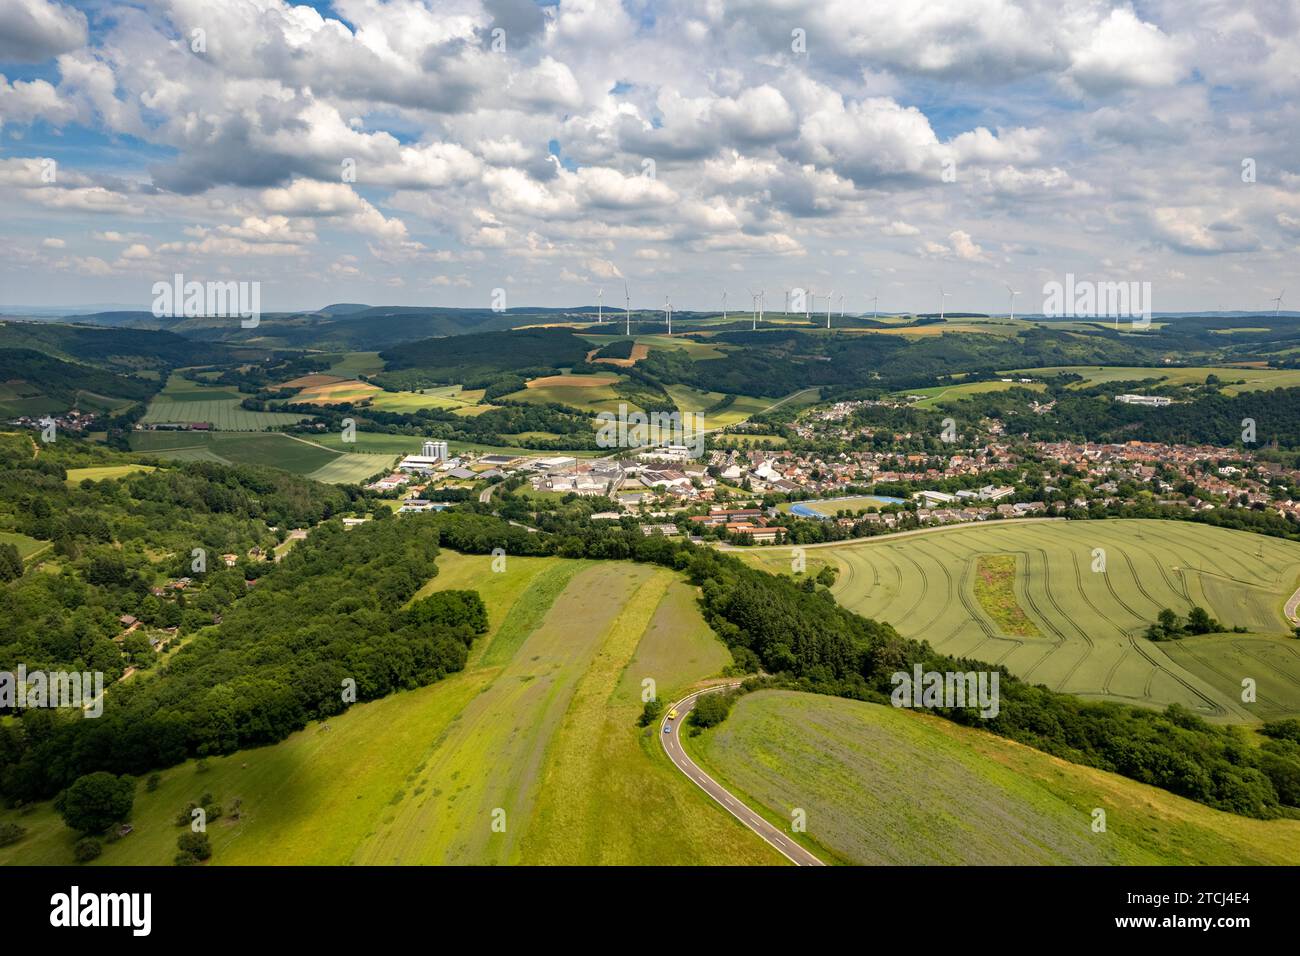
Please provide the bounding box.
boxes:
[131,432,397,484]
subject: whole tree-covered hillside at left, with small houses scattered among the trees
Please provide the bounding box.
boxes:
[0,436,486,801]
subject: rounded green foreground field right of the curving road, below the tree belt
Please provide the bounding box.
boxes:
[688,691,1300,866]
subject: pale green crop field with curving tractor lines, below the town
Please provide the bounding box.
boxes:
[741,520,1300,722]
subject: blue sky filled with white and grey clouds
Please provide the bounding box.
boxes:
[0,0,1300,313]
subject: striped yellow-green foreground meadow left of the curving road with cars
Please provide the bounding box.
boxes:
[0,551,759,865]
